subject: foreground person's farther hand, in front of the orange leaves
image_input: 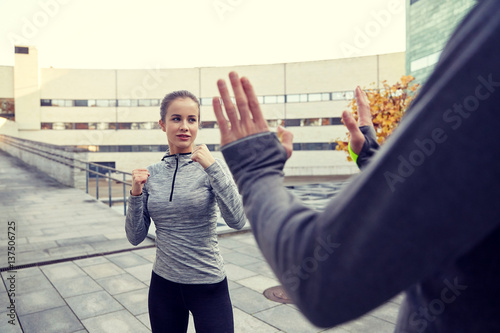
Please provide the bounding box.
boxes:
[342,86,373,154]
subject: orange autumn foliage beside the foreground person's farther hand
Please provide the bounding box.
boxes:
[335,75,419,161]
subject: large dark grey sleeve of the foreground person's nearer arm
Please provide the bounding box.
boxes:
[222,1,500,327]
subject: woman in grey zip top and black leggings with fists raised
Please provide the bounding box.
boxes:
[125,91,246,333]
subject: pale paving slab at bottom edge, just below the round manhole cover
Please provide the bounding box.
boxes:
[254,304,320,333]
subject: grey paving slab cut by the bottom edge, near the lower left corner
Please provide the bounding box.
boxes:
[19,306,83,333]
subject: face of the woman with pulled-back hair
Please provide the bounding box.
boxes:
[159,98,199,154]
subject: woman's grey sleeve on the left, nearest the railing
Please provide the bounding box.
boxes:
[125,185,151,245]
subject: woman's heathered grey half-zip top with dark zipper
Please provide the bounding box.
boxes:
[125,150,246,284]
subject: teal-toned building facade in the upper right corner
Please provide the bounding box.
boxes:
[406,0,477,83]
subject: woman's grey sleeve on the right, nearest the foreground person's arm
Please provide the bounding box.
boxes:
[205,159,246,230]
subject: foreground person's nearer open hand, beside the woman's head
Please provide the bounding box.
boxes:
[212,72,293,157]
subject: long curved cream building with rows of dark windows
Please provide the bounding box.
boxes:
[0,46,405,176]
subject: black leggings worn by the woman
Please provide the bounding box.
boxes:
[148,272,234,333]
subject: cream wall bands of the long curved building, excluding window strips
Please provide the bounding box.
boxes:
[0,49,405,175]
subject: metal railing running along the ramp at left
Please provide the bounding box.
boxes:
[0,135,132,215]
